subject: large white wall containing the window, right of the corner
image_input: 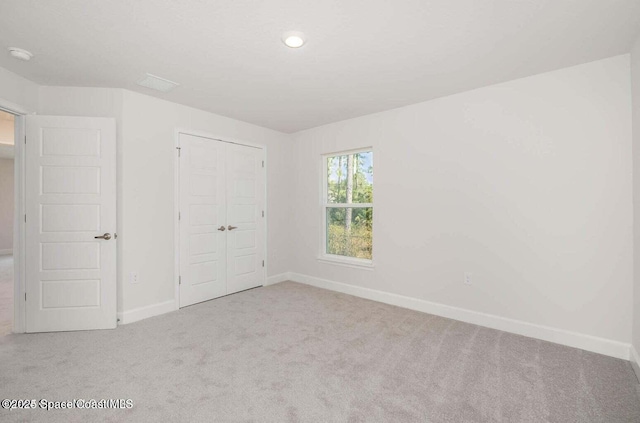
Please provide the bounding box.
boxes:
[291,55,633,343]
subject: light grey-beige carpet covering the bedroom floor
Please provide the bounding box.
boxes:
[0,282,640,423]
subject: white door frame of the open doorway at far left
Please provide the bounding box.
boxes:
[0,98,35,333]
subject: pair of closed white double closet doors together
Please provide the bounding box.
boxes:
[177,132,266,307]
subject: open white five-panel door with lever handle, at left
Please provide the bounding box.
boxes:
[25,116,116,332]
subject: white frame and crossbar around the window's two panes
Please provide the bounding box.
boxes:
[318,147,375,269]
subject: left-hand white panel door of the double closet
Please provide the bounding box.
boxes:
[179,134,227,307]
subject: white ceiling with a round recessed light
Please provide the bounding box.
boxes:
[0,0,640,132]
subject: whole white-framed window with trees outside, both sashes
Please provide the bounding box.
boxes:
[321,149,373,265]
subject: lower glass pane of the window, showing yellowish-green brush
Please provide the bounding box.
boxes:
[327,207,373,260]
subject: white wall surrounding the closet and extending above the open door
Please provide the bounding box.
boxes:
[38,87,291,315]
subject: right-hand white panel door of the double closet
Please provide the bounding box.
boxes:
[227,144,265,294]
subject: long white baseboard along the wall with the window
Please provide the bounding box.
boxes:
[289,272,640,363]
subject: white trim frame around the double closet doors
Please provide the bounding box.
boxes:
[173,128,269,310]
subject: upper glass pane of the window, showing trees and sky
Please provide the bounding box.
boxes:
[327,151,373,204]
